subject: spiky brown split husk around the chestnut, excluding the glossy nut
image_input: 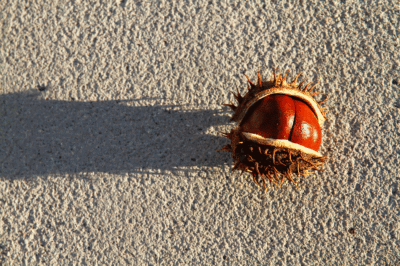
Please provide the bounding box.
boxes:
[220,69,328,189]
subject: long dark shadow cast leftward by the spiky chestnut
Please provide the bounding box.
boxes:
[0,90,230,179]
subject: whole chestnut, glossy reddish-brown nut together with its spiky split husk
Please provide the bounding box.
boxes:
[220,69,328,189]
